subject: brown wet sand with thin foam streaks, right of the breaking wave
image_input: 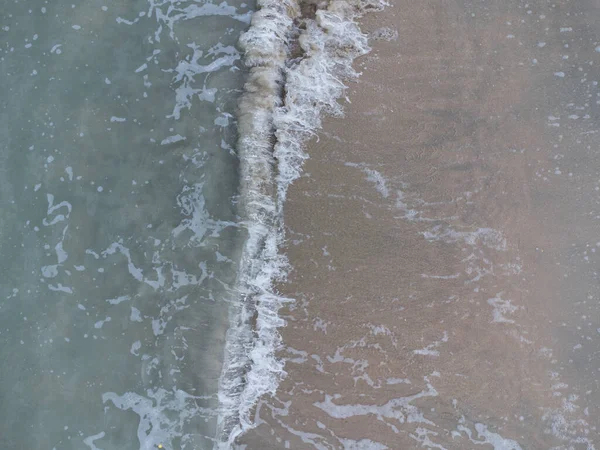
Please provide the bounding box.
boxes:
[239,0,600,449]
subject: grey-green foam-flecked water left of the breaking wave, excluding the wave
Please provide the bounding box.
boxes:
[0,0,250,450]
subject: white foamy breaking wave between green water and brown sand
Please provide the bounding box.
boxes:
[215,0,384,449]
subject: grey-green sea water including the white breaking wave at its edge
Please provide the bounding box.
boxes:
[0,0,383,450]
